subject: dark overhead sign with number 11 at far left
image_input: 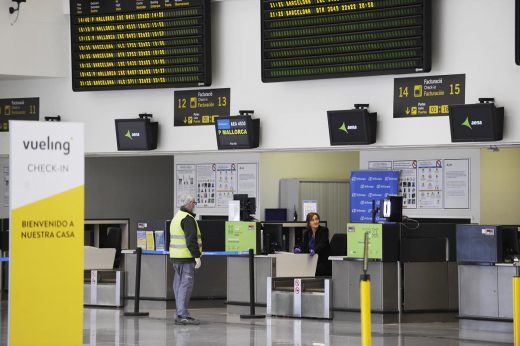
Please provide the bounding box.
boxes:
[0,97,40,132]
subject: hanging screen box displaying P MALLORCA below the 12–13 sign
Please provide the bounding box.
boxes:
[215,115,260,150]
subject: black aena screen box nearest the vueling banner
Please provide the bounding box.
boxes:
[115,118,159,150]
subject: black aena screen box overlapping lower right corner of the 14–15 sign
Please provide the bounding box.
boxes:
[450,103,504,142]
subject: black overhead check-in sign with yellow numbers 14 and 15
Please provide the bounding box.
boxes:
[394,74,466,118]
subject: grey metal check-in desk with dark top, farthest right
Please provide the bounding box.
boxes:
[457,225,520,332]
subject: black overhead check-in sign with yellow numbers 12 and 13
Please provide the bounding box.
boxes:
[173,88,231,126]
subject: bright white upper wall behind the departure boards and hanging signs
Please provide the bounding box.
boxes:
[0,0,520,154]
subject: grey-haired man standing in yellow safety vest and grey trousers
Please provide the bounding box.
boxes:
[170,195,202,325]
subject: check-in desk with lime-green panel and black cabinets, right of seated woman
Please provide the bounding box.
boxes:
[330,224,458,323]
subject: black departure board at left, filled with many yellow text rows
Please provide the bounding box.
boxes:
[70,0,211,91]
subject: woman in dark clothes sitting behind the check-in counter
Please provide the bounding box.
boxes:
[301,213,332,276]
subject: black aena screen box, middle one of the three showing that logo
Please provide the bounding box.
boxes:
[327,109,377,145]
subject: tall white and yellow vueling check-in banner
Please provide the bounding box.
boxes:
[8,121,85,346]
